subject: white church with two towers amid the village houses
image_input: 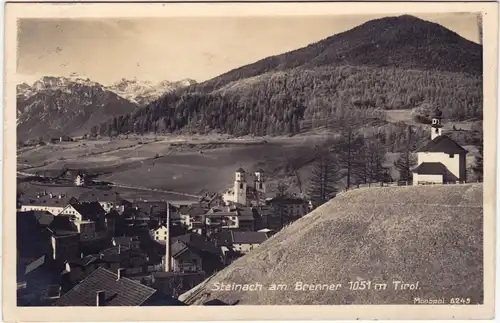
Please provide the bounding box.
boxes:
[222,167,266,206]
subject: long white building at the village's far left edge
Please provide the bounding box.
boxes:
[21,192,78,215]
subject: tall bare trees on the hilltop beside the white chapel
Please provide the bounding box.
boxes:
[307,126,483,207]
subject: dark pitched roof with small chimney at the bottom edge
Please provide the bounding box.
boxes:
[55,268,182,306]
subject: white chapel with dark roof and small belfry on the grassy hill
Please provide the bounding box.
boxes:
[412,110,467,185]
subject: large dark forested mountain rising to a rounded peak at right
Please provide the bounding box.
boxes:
[18,15,482,142]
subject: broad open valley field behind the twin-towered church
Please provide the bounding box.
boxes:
[18,133,482,198]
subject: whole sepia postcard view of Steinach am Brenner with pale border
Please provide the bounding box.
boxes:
[4,3,498,318]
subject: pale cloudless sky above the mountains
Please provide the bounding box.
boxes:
[17,13,479,85]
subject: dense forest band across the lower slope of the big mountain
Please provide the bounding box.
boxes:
[95,66,482,147]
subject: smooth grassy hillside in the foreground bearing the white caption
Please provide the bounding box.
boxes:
[181,184,483,305]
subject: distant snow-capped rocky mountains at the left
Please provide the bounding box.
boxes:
[17,74,196,140]
